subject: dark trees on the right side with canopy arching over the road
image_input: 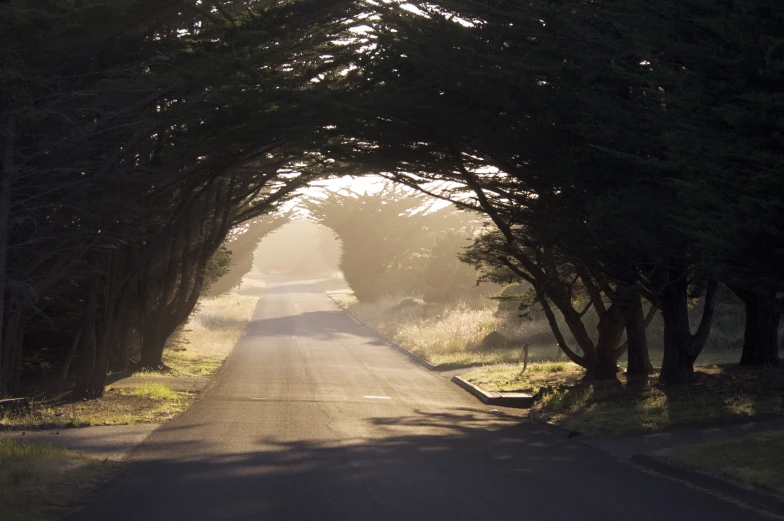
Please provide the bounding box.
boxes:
[314,0,784,383]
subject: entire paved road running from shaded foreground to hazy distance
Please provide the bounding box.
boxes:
[71,282,776,521]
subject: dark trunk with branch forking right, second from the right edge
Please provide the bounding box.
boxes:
[659,280,693,385]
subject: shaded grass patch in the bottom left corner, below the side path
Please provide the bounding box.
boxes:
[0,436,111,521]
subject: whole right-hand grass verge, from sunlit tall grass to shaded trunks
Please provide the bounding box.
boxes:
[332,292,784,435]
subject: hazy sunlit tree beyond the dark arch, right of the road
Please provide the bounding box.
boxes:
[306,185,482,302]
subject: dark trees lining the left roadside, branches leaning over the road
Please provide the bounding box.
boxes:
[0,0,362,397]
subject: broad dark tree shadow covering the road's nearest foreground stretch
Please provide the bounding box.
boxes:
[69,406,754,521]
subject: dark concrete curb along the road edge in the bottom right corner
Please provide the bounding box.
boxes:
[629,454,784,517]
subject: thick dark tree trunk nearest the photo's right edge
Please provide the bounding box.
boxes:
[733,290,781,366]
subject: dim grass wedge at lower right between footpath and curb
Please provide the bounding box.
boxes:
[657,432,784,495]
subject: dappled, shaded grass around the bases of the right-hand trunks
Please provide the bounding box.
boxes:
[535,366,784,435]
